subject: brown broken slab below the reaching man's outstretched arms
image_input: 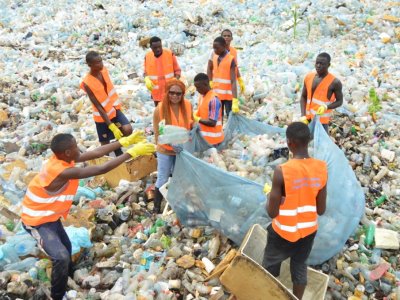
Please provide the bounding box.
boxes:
[88,155,157,188]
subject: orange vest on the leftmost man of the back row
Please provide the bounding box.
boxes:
[80,67,121,123]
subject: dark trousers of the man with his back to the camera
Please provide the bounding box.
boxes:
[263,225,317,285]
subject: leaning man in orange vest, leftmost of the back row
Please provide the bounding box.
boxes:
[80,51,132,156]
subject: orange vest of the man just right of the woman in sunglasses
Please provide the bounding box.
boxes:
[197,90,224,145]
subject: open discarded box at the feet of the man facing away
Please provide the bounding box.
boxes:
[220,224,329,300]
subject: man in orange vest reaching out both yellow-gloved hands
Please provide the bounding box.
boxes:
[21,131,155,300]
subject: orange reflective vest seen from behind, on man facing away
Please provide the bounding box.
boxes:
[272,158,328,242]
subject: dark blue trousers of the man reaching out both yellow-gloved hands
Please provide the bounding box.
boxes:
[24,220,72,300]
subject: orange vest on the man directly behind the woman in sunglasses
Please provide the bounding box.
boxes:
[144,48,174,101]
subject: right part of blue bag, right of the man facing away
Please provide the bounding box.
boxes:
[308,121,365,265]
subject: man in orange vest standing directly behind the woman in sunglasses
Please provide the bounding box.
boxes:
[144,36,181,106]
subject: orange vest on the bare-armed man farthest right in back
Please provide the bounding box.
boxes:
[304,72,336,124]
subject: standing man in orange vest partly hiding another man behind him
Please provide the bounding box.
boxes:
[208,36,239,117]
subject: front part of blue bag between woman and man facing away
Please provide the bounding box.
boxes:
[167,151,271,245]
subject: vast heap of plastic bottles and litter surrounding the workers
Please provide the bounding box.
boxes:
[0,0,400,299]
